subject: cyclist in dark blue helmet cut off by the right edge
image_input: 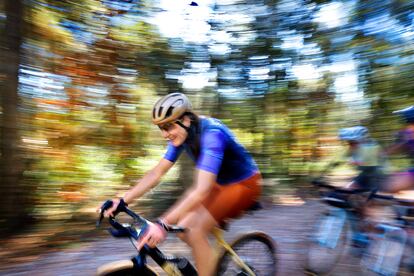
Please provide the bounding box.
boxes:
[382,106,414,193]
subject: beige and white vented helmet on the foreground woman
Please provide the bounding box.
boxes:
[152,93,191,125]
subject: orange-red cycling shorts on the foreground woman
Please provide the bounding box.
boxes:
[203,172,262,223]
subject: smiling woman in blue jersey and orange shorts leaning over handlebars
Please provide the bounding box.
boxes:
[101,93,262,275]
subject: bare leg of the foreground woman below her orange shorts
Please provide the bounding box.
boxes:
[178,206,217,276]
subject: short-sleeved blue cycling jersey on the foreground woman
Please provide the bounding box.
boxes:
[164,118,258,185]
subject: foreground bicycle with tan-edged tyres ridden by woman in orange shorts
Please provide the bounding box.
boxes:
[97,200,276,276]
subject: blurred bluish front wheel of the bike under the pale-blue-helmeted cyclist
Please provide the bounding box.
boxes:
[305,209,350,275]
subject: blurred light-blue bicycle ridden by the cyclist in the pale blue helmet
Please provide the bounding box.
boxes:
[305,178,374,275]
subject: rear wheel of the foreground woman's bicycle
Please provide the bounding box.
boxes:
[216,232,276,276]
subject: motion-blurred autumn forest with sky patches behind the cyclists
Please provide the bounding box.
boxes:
[0,0,414,233]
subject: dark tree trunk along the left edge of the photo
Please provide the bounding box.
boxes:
[0,0,24,231]
